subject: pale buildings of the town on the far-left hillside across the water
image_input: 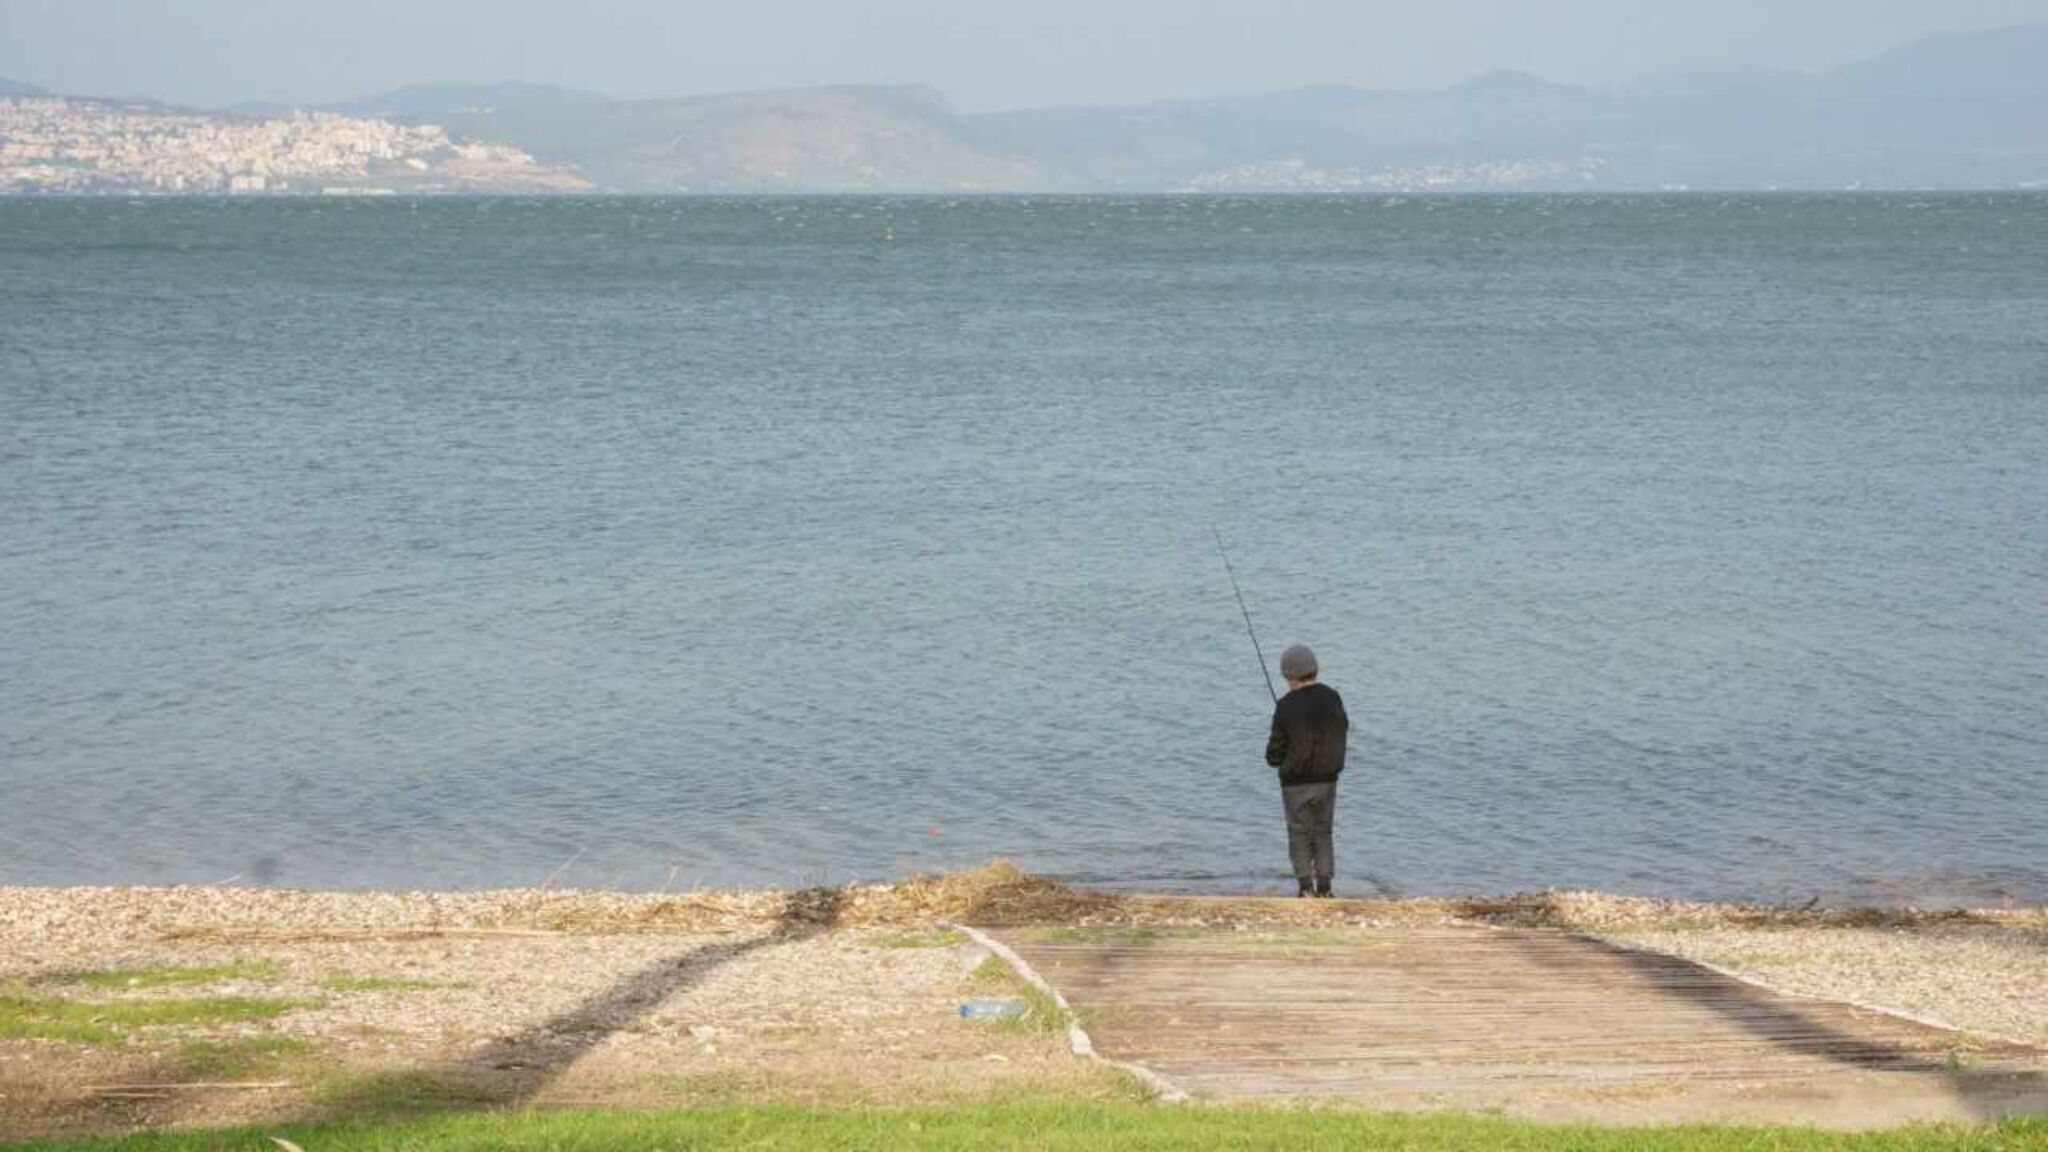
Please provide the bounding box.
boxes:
[0,96,590,195]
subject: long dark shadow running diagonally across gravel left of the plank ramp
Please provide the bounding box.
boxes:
[319,888,844,1119]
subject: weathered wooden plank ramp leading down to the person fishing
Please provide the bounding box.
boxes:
[991,924,2048,1127]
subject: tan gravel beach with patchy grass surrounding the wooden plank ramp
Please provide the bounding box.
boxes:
[0,865,2048,1140]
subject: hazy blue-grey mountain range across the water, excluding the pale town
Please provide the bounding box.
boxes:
[0,27,2048,193]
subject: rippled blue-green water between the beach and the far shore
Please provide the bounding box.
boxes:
[0,195,2048,902]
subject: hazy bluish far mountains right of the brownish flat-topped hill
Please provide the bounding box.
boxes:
[975,29,2048,191]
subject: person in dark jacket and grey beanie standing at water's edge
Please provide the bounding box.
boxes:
[1266,644,1352,898]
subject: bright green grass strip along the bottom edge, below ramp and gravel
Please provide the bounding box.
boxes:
[8,1105,2048,1152]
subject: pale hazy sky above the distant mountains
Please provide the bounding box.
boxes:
[0,0,2048,111]
